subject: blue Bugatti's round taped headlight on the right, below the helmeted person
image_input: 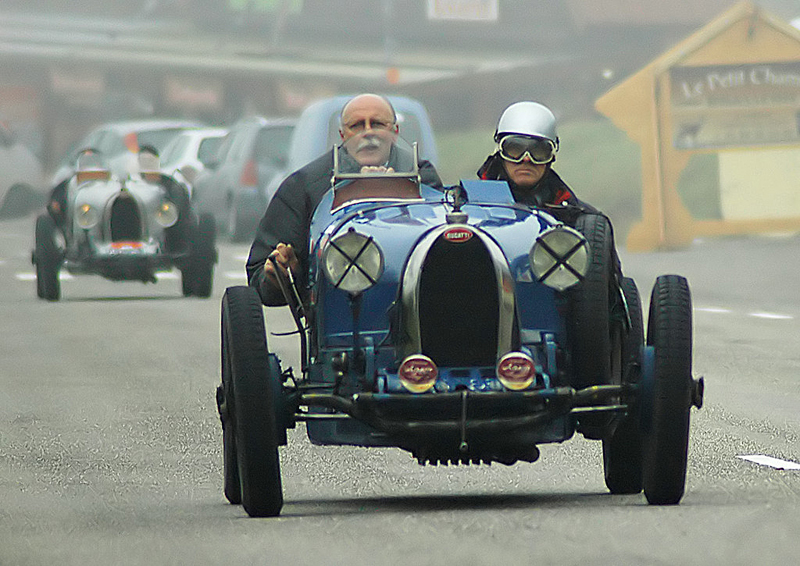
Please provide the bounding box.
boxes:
[530,226,589,291]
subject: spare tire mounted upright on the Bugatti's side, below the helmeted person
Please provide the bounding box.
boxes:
[569,214,614,389]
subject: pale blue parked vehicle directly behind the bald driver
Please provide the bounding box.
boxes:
[260,96,438,211]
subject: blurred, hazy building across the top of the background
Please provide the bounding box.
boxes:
[0,0,800,172]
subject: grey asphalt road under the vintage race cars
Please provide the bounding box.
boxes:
[0,217,800,566]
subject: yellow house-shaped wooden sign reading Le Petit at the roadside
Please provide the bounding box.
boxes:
[595,2,800,251]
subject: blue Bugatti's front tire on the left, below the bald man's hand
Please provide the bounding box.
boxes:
[222,286,283,517]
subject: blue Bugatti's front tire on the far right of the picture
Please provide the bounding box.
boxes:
[643,275,692,505]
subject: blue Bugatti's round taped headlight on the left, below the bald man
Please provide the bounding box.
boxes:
[322,228,383,295]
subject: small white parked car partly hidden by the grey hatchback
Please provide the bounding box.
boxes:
[161,128,228,197]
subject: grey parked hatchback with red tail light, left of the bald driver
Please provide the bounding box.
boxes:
[193,116,295,241]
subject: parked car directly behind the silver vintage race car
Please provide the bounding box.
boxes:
[51,119,205,186]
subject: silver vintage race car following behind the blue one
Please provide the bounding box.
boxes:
[32,150,217,301]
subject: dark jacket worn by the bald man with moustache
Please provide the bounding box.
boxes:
[247,149,442,306]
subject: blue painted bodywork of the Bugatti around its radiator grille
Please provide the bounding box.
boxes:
[296,181,574,452]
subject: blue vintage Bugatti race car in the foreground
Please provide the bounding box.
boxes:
[217,143,703,516]
